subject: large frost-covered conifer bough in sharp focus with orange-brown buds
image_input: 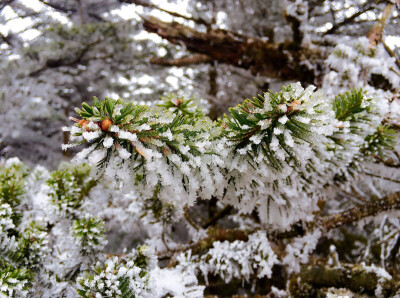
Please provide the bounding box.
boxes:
[64,83,395,228]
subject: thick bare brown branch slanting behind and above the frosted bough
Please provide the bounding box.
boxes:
[143,16,323,83]
